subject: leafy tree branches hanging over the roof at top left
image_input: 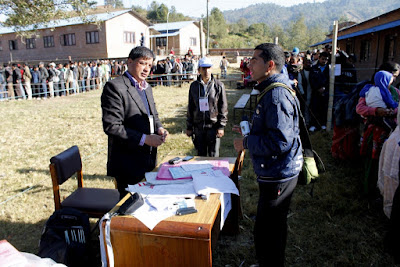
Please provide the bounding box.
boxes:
[0,0,96,36]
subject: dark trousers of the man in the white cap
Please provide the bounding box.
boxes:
[193,128,221,157]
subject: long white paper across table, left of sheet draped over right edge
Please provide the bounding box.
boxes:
[128,182,197,198]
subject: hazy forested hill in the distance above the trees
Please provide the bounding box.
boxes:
[223,0,400,28]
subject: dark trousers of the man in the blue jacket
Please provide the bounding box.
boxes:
[254,177,297,267]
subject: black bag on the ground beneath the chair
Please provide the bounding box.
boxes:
[38,208,90,267]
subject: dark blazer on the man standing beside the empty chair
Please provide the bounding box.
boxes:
[101,75,162,183]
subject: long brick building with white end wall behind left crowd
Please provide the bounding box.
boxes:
[0,10,151,62]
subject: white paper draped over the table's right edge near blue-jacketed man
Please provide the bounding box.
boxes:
[192,171,239,195]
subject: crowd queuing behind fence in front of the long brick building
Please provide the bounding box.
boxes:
[0,60,127,101]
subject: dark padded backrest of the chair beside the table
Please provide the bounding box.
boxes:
[49,146,83,210]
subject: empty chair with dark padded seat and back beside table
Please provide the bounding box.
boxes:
[49,146,119,218]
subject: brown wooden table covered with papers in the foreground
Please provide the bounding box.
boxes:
[103,156,236,267]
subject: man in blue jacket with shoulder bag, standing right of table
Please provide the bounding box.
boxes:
[234,43,303,267]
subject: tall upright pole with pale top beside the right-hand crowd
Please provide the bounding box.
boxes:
[326,20,338,131]
